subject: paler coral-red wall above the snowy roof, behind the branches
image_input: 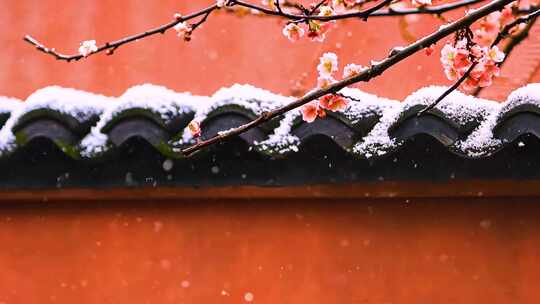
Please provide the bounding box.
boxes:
[0,0,506,98]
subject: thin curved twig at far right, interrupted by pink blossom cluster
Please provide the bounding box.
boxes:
[417,5,540,116]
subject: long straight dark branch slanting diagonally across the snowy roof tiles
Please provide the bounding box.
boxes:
[182,0,515,156]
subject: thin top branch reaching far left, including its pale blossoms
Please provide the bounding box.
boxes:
[23,0,485,62]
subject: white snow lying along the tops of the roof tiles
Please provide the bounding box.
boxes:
[0,83,540,158]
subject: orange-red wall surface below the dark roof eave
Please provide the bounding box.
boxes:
[0,198,540,304]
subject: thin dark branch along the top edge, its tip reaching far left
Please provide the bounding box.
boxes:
[23,0,485,62]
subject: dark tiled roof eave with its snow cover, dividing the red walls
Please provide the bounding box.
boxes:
[0,84,540,189]
